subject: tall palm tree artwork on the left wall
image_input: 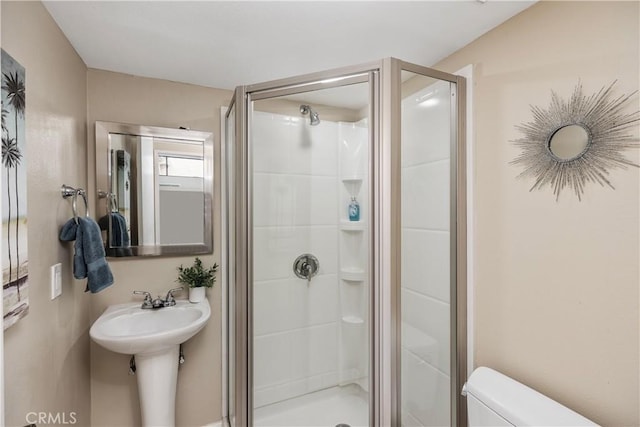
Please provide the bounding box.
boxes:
[0,50,29,329]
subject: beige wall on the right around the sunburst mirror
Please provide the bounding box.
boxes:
[435,2,640,426]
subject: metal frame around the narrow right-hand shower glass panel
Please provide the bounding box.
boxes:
[388,58,468,427]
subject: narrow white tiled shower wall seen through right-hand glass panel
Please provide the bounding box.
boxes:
[401,82,450,427]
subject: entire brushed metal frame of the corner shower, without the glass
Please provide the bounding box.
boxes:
[222,58,466,427]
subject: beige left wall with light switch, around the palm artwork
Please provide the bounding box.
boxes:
[0,1,92,426]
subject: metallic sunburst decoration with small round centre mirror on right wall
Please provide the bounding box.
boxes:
[511,81,640,200]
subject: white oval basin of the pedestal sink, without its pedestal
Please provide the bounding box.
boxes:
[89,299,211,355]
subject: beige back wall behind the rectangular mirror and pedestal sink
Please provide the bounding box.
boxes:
[87,69,231,426]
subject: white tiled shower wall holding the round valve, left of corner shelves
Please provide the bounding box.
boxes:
[252,112,340,407]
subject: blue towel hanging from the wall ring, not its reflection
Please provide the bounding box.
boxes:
[60,217,113,294]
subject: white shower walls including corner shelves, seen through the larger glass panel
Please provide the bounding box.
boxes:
[252,108,368,407]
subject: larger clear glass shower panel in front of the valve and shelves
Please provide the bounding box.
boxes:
[248,82,370,426]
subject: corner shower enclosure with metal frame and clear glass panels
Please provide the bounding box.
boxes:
[223,58,466,426]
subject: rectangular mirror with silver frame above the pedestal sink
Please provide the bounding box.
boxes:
[96,122,213,257]
